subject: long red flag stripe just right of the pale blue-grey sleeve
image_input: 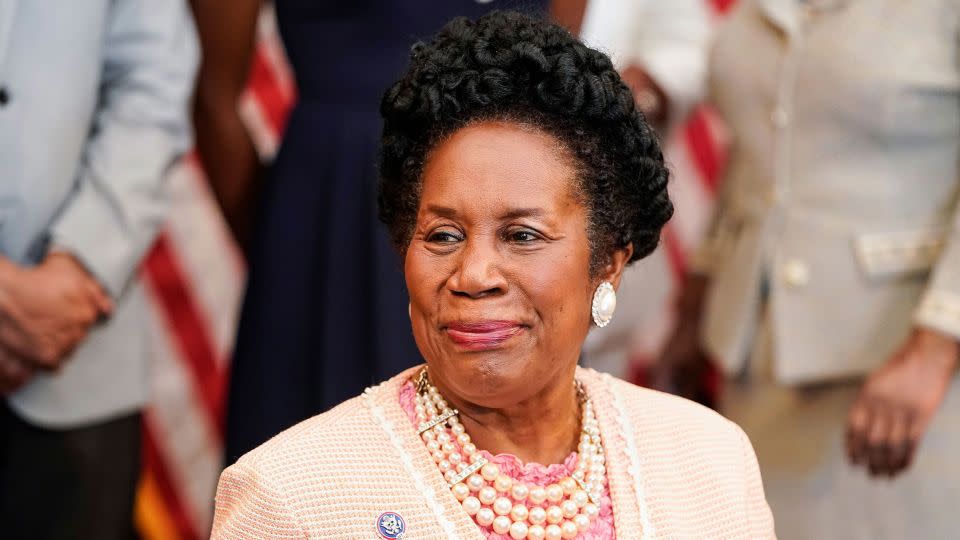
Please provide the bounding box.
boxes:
[144,234,226,438]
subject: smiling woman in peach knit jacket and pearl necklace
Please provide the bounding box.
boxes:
[213,12,773,540]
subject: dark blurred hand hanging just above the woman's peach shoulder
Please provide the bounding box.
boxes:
[649,275,710,400]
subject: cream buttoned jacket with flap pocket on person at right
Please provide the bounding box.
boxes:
[698,0,960,383]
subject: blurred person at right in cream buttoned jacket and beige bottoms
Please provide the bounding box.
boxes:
[658,0,960,539]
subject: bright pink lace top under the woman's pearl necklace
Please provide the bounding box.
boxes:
[400,381,616,540]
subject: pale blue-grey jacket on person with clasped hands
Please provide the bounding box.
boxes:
[0,0,198,427]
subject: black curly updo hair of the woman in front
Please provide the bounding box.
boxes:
[378,11,673,275]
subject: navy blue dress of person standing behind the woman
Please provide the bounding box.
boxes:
[226,0,547,463]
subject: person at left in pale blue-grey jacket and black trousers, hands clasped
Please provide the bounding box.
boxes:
[0,0,199,539]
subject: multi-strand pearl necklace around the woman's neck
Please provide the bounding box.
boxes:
[415,369,606,540]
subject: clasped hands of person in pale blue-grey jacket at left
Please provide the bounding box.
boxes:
[0,253,113,370]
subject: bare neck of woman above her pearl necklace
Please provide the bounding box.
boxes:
[440,374,581,465]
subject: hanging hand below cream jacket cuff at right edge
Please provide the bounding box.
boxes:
[846,329,960,477]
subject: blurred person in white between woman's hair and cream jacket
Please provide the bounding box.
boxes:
[581,0,711,377]
